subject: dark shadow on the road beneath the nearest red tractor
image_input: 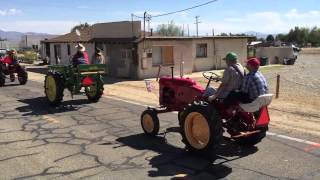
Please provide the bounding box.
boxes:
[115,134,258,179]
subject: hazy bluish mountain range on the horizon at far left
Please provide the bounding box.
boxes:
[0,30,57,48]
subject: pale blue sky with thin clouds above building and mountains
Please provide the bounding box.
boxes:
[0,0,320,35]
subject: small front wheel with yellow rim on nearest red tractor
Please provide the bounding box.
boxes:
[141,109,160,136]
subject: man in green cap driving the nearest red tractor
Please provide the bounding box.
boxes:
[208,52,245,101]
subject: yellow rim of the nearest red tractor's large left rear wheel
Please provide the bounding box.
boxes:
[184,112,210,149]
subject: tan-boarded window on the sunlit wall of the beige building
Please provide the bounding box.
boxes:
[152,46,174,65]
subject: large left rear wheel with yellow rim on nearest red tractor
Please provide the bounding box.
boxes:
[179,102,223,156]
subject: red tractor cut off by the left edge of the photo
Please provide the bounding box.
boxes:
[0,61,28,87]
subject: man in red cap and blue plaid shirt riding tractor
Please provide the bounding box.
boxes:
[224,58,268,106]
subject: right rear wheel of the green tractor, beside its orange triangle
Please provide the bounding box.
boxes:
[85,76,104,102]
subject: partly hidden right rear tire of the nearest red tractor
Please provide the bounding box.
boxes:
[235,127,268,146]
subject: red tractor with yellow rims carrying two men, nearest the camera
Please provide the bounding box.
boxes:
[141,68,272,154]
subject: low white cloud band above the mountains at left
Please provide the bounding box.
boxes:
[0,21,79,34]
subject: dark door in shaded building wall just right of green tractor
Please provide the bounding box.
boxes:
[117,49,132,78]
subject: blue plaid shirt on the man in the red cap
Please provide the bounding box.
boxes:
[240,71,268,100]
